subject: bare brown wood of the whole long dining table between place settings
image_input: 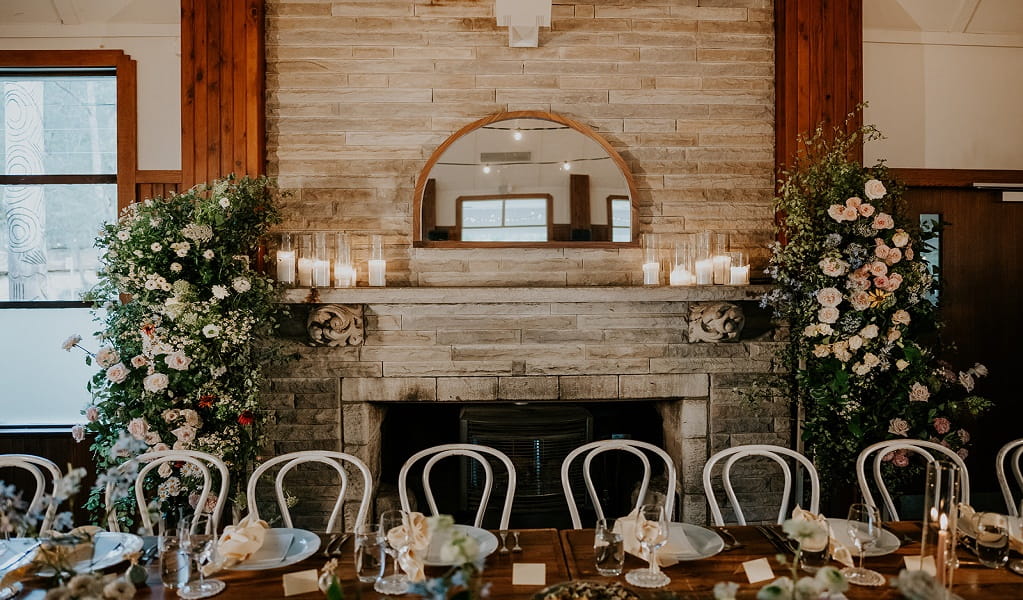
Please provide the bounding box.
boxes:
[19,522,1023,600]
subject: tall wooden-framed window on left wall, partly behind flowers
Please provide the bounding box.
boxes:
[0,50,137,425]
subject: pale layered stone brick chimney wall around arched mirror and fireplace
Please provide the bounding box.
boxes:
[266,0,789,520]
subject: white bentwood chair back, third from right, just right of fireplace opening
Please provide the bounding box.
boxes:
[703,444,820,526]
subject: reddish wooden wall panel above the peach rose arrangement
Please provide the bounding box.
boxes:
[774,0,863,166]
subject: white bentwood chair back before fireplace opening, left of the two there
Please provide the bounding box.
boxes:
[398,444,516,529]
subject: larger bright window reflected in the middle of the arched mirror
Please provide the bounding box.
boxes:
[455,194,553,242]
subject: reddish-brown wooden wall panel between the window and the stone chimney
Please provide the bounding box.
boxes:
[181,0,266,188]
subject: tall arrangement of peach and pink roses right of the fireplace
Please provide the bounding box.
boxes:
[764,119,989,494]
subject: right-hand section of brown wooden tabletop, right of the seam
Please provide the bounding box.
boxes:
[561,522,1023,600]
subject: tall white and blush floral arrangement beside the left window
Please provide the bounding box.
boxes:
[63,176,279,517]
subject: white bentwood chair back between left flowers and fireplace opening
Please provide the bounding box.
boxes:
[246,450,373,533]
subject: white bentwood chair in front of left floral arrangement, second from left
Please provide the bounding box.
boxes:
[104,450,231,536]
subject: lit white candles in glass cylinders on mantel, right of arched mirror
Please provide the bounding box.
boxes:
[642,231,750,285]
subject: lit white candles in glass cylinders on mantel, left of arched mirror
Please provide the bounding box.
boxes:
[277,231,387,287]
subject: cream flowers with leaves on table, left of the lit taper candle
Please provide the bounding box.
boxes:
[714,518,849,600]
